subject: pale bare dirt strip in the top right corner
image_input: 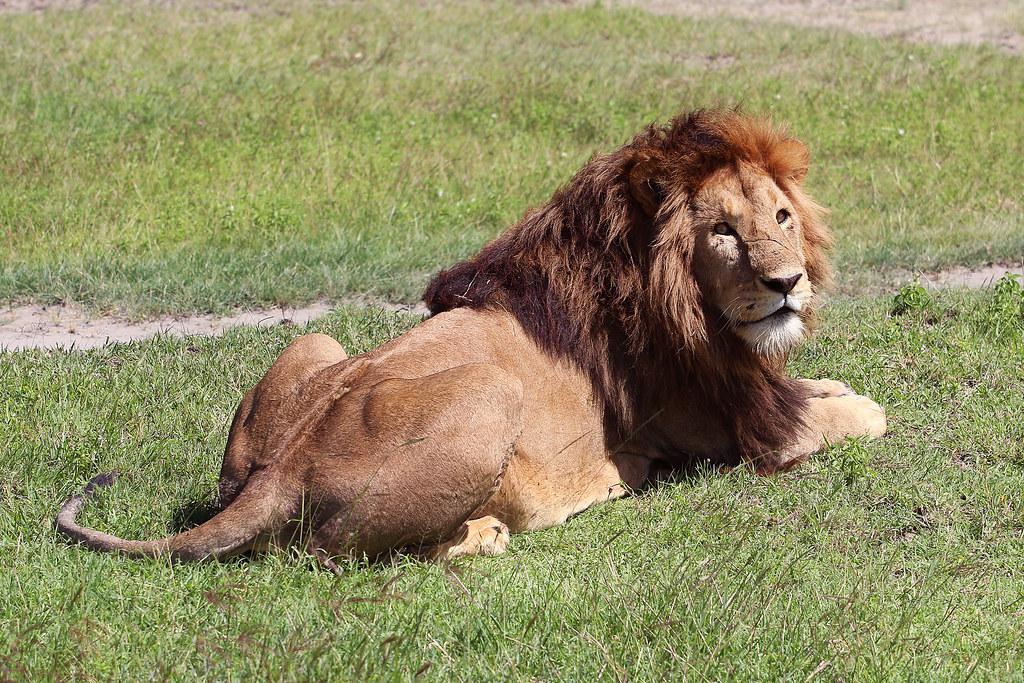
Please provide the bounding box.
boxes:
[602,0,1024,54]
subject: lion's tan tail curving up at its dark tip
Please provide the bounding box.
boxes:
[56,472,291,560]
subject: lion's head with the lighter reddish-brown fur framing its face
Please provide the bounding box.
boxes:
[628,112,830,356]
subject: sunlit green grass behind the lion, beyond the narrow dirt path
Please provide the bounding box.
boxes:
[0,2,1024,314]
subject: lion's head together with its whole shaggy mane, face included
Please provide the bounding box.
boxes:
[424,111,829,450]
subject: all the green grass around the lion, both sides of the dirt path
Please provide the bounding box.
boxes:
[0,2,1024,681]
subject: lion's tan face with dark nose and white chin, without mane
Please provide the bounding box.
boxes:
[690,162,814,356]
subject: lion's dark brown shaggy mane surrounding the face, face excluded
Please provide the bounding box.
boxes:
[424,111,828,459]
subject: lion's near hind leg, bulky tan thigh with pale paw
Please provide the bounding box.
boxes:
[309,364,522,568]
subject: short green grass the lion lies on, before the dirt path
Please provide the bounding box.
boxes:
[0,280,1024,681]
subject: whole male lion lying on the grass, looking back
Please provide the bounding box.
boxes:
[56,111,886,571]
